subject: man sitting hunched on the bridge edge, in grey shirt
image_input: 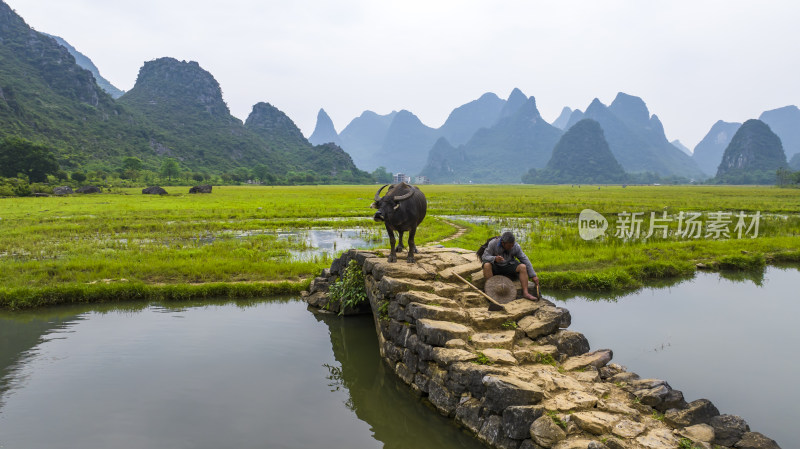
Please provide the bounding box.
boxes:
[481,232,539,300]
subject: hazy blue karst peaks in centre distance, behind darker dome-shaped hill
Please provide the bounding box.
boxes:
[320,89,744,183]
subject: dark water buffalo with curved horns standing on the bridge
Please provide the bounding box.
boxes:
[370,182,428,263]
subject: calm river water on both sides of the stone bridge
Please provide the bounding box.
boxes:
[0,267,800,449]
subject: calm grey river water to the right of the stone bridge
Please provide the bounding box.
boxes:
[552,267,800,449]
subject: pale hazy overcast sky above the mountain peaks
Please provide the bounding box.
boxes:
[6,0,800,148]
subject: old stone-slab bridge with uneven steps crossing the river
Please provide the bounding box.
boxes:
[304,247,778,449]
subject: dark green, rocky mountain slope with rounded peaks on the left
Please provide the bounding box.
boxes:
[0,0,372,183]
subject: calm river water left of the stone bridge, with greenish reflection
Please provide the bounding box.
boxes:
[0,300,482,449]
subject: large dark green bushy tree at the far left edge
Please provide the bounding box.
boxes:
[0,137,59,182]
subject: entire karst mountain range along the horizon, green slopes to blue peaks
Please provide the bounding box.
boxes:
[0,0,800,183]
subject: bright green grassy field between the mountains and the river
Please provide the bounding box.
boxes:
[0,186,800,308]
